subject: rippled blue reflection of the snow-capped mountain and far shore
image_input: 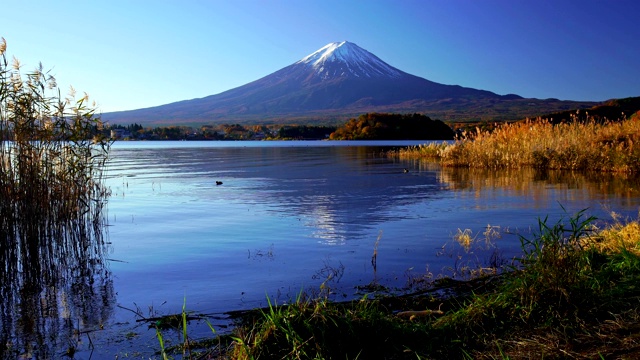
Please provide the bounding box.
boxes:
[111,145,450,244]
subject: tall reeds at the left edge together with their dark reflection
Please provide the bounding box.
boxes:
[0,38,112,358]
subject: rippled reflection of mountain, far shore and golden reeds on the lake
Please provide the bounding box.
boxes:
[107,145,640,248]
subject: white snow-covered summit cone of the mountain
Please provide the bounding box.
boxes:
[296,41,402,79]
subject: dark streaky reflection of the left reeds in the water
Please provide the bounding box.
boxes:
[0,205,115,359]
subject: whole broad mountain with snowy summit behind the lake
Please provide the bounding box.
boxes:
[102,41,594,126]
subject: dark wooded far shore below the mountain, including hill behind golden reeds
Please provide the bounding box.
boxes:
[100,97,640,140]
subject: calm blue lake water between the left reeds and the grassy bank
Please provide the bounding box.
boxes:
[7,141,640,359]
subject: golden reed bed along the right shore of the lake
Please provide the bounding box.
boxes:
[390,115,640,173]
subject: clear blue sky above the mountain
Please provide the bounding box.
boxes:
[0,0,640,112]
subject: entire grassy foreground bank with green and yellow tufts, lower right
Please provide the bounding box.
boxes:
[230,212,640,359]
